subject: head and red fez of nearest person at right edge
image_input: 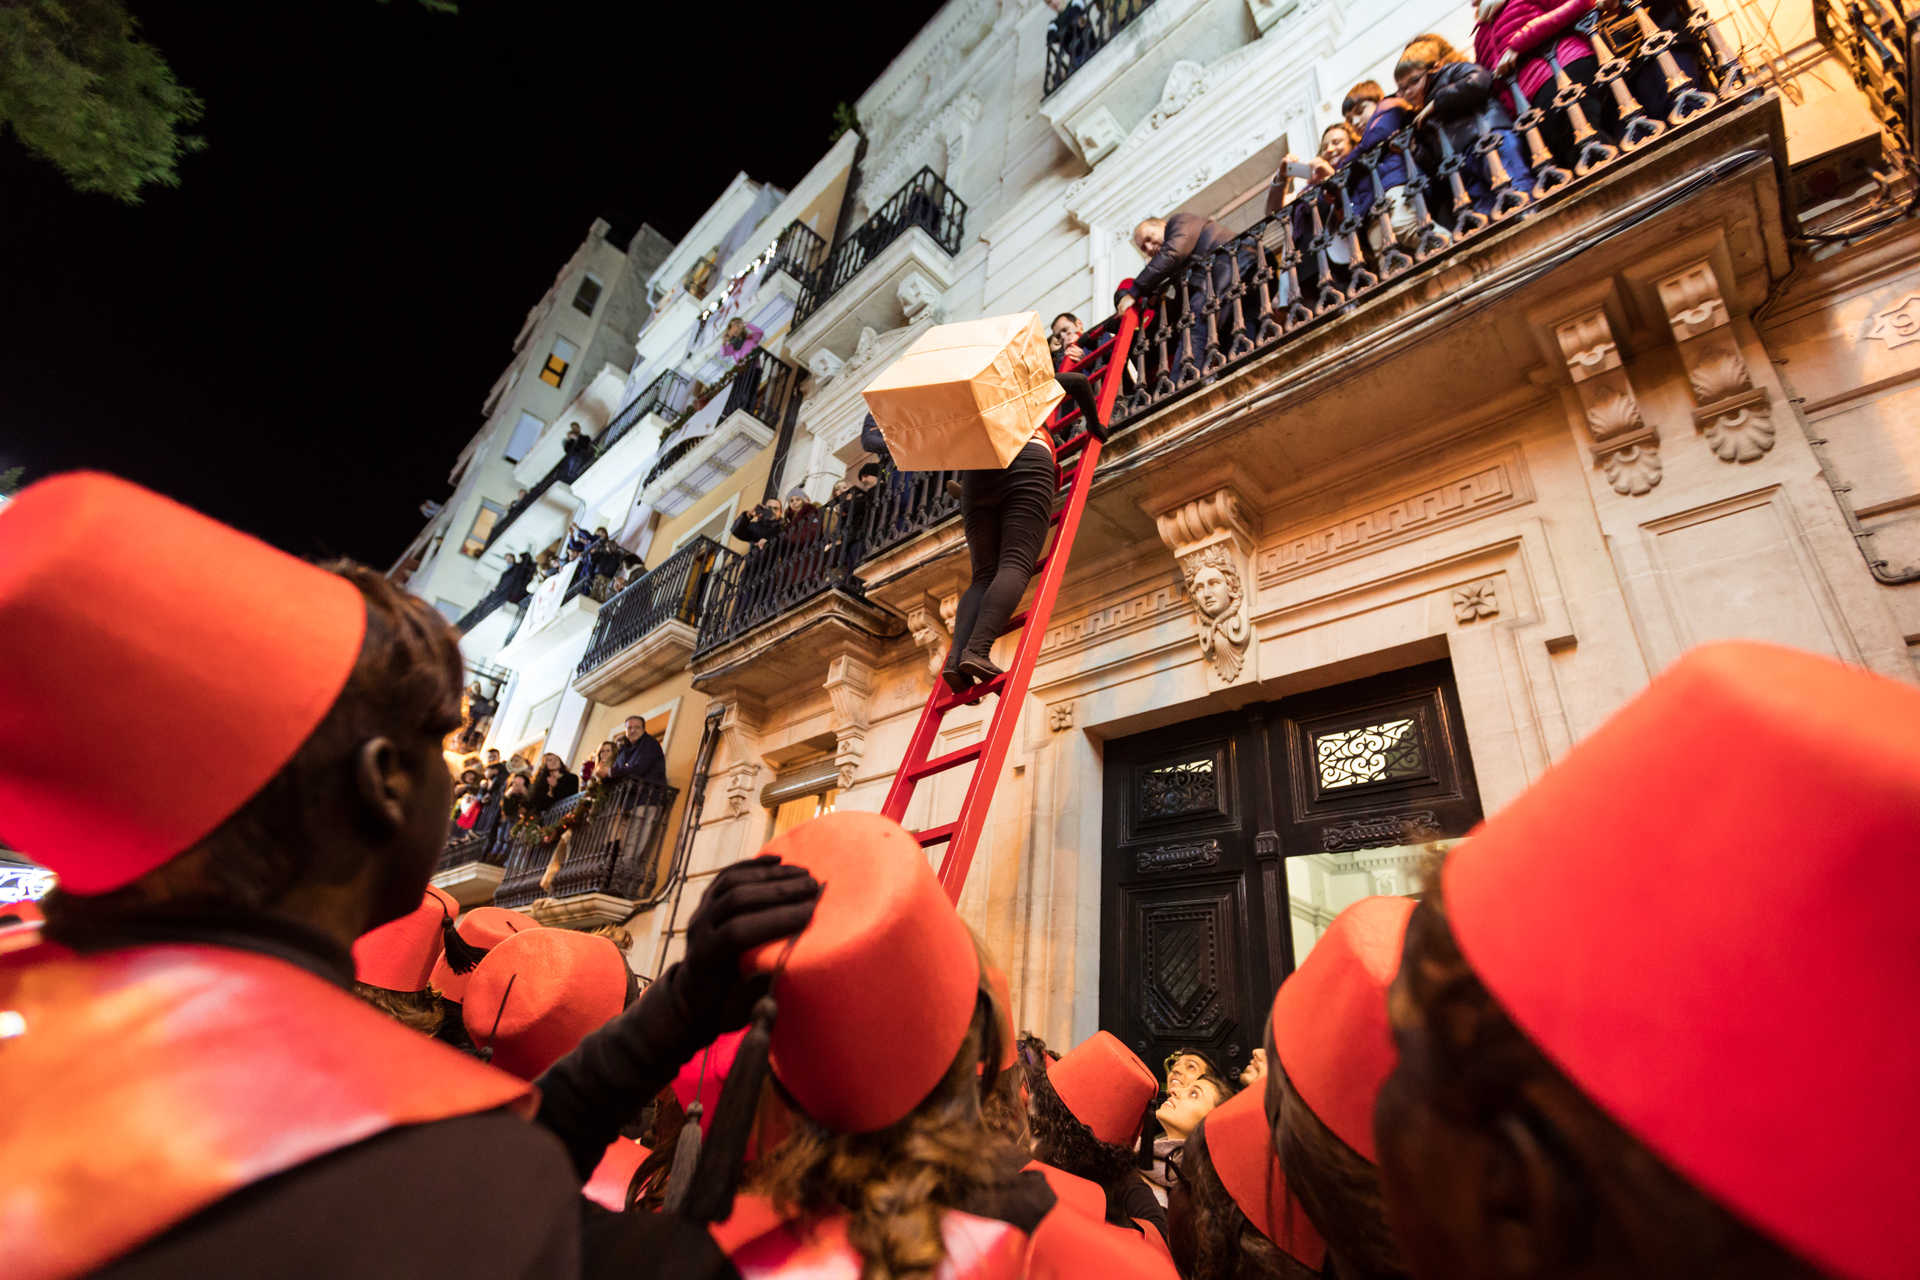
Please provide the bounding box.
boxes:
[1375,643,1920,1280]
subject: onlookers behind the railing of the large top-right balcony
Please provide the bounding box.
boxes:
[1116,0,1713,378]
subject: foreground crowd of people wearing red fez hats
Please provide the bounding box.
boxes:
[0,474,1920,1280]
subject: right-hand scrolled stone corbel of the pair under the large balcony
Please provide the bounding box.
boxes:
[1655,257,1774,462]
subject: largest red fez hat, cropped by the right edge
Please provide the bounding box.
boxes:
[1442,643,1920,1278]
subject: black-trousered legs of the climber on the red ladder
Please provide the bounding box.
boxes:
[947,443,1054,666]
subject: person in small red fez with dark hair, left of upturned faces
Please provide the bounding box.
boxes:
[1027,1031,1167,1242]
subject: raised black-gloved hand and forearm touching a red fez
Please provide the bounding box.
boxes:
[534,854,820,1182]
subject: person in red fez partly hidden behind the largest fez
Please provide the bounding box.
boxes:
[1265,898,1413,1278]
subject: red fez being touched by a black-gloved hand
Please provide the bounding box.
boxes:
[749,810,979,1134]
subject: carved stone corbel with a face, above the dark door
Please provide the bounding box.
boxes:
[1154,486,1260,689]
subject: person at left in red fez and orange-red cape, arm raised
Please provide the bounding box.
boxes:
[0,472,812,1280]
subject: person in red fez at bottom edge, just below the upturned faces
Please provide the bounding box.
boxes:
[1167,1092,1327,1280]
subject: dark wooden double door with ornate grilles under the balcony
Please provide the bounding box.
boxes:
[1100,662,1480,1073]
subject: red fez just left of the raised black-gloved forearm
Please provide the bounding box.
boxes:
[461,929,628,1080]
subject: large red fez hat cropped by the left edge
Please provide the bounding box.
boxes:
[0,472,367,894]
